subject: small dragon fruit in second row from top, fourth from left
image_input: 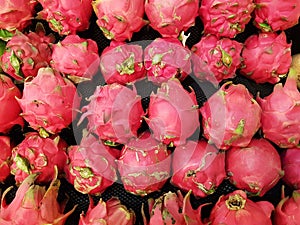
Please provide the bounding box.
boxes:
[144,38,192,85]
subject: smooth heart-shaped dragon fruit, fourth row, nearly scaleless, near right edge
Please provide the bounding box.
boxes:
[225,139,284,196]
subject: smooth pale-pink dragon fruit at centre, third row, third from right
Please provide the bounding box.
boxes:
[146,78,200,146]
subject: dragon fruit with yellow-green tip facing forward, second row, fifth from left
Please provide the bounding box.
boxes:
[192,35,243,85]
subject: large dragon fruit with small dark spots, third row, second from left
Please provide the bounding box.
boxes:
[18,67,79,137]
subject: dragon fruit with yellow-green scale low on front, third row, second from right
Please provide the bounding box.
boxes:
[200,82,261,150]
